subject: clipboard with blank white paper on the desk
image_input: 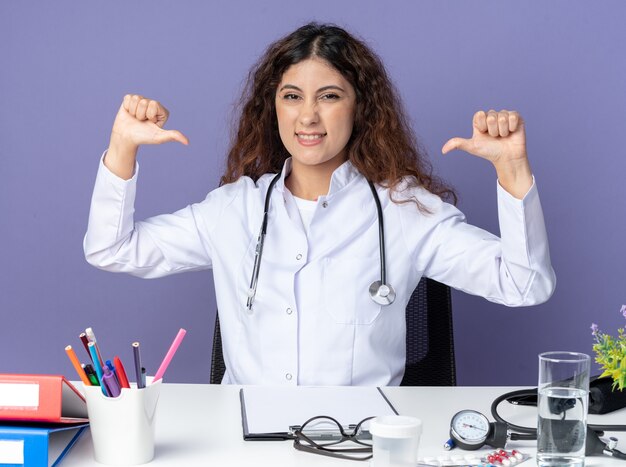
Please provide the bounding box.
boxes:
[239,386,398,441]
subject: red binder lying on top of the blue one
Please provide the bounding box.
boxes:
[0,374,88,423]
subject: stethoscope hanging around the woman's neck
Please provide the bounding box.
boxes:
[246,173,396,313]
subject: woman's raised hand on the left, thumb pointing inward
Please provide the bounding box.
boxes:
[104,94,189,180]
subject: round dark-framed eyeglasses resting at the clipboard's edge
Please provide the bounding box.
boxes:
[293,415,374,461]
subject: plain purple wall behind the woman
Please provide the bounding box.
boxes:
[0,0,626,385]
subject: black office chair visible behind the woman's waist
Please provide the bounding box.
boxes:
[210,278,456,386]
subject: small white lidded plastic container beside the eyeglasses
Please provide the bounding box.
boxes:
[369,415,422,467]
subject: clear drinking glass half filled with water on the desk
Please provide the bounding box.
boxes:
[537,352,590,467]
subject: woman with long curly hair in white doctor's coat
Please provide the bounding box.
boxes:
[84,24,555,385]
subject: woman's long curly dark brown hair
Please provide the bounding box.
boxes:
[220,23,457,206]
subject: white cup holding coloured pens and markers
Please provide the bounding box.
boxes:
[85,377,161,465]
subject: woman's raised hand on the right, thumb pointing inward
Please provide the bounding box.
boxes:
[441,110,532,199]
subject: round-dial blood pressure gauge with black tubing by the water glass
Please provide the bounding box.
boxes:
[444,389,626,460]
